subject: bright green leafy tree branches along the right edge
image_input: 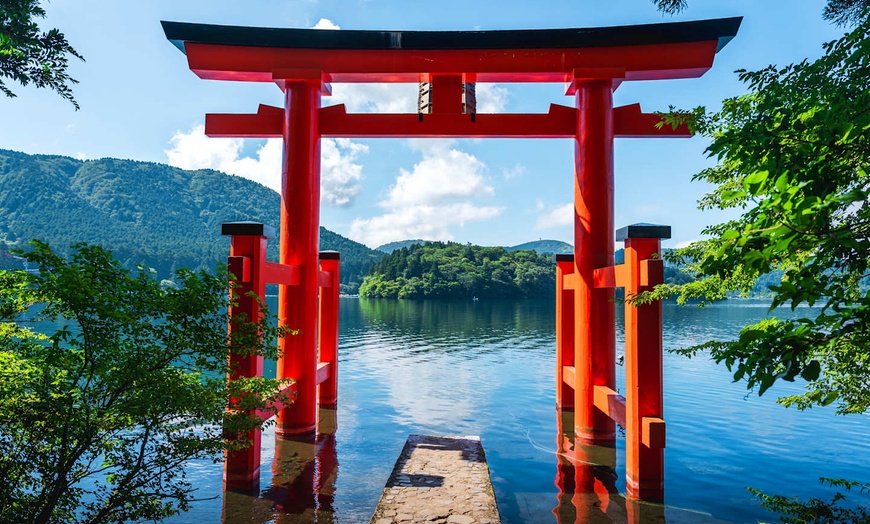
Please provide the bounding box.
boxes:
[635,6,870,524]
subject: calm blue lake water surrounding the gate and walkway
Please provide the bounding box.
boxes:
[171,298,870,523]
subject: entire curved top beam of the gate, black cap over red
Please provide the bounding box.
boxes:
[162,17,742,82]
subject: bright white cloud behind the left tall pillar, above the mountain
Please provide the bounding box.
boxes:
[166,125,368,207]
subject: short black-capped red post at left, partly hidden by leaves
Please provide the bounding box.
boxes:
[222,222,275,491]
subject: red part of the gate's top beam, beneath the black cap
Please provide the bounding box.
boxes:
[184,40,719,83]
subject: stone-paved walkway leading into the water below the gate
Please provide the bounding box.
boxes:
[370,435,501,524]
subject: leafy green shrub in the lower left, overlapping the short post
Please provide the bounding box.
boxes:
[0,243,292,523]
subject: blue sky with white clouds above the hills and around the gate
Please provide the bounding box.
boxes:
[0,0,843,247]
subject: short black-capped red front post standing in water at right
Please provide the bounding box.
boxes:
[617,224,670,502]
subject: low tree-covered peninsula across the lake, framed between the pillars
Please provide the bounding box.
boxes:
[359,242,556,298]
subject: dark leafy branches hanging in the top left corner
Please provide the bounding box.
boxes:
[0,0,84,109]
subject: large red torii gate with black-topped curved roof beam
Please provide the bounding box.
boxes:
[162,18,741,499]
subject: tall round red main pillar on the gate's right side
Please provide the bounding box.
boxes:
[574,80,616,445]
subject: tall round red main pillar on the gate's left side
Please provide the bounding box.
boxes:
[275,80,321,437]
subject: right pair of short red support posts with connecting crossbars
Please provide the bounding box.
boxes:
[556,224,671,501]
